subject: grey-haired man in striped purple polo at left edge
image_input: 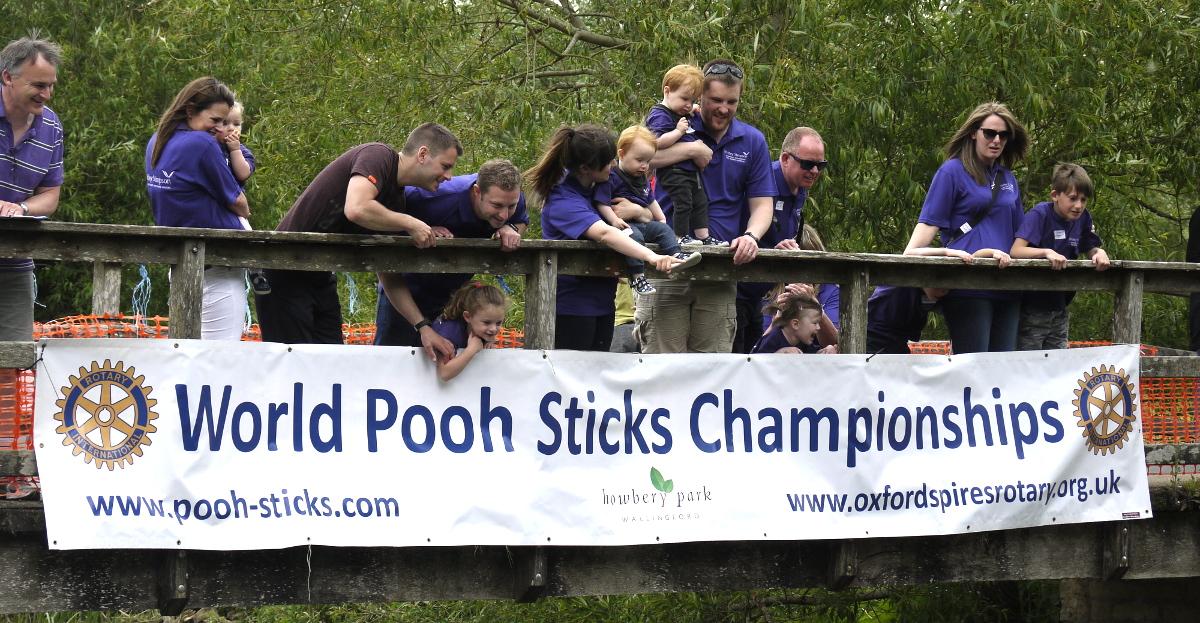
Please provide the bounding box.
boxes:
[0,35,62,342]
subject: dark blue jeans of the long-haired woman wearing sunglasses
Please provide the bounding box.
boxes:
[942,298,1021,354]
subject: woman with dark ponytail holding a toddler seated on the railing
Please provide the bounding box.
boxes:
[526,124,680,352]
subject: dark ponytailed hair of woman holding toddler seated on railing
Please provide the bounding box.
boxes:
[524,124,617,200]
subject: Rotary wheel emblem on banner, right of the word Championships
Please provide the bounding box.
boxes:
[1070,365,1138,455]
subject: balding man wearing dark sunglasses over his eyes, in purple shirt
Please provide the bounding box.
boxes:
[733,127,829,353]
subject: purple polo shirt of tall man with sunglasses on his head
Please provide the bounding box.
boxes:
[654,115,775,240]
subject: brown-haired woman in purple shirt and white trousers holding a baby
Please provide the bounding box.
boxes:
[145,77,250,340]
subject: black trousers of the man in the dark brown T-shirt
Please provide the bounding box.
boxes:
[254,270,342,345]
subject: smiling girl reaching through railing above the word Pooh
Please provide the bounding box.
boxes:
[433,281,509,383]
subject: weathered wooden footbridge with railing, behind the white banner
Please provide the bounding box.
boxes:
[0,220,1200,621]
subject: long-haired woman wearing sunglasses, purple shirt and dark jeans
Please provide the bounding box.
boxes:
[905,102,1028,354]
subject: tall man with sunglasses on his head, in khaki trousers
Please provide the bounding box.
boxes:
[635,60,775,353]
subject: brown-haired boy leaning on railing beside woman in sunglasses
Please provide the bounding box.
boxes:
[1010,163,1109,351]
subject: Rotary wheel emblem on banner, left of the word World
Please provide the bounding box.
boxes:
[54,359,158,471]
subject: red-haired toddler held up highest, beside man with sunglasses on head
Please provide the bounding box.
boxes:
[646,65,728,246]
